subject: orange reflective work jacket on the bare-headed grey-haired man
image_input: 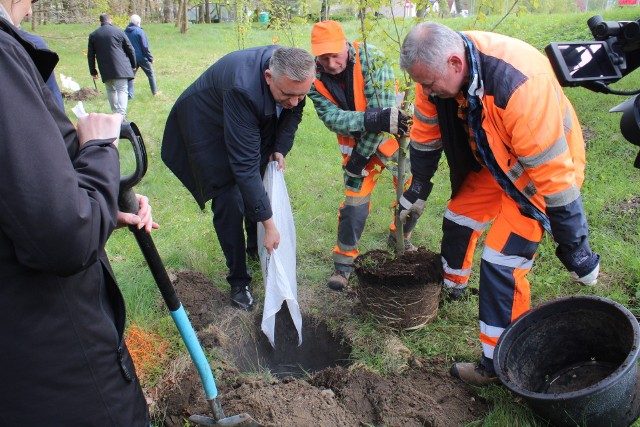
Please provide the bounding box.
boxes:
[411,31,585,217]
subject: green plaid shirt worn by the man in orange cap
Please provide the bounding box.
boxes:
[309,43,397,163]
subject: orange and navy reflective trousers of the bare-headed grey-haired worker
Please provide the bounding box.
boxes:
[441,167,544,359]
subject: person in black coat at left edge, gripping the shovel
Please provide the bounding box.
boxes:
[0,0,157,427]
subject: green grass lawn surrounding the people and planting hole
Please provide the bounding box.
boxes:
[37,8,640,426]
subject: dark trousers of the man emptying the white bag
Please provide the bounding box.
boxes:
[211,185,251,288]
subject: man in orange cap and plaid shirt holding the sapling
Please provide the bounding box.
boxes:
[309,21,415,290]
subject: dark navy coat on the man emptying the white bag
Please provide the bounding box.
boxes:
[162,46,305,222]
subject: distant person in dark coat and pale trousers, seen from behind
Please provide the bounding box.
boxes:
[87,13,136,119]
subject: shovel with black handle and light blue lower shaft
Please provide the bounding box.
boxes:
[118,122,263,427]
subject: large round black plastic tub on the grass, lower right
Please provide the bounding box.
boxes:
[493,296,640,427]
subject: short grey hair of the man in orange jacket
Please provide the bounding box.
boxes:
[400,22,464,73]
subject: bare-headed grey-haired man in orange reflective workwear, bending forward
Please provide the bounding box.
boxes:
[400,22,600,385]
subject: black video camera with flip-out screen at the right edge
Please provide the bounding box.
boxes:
[545,15,640,169]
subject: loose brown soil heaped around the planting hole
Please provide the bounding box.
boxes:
[145,271,489,427]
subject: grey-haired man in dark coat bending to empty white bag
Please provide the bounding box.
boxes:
[162,46,315,310]
